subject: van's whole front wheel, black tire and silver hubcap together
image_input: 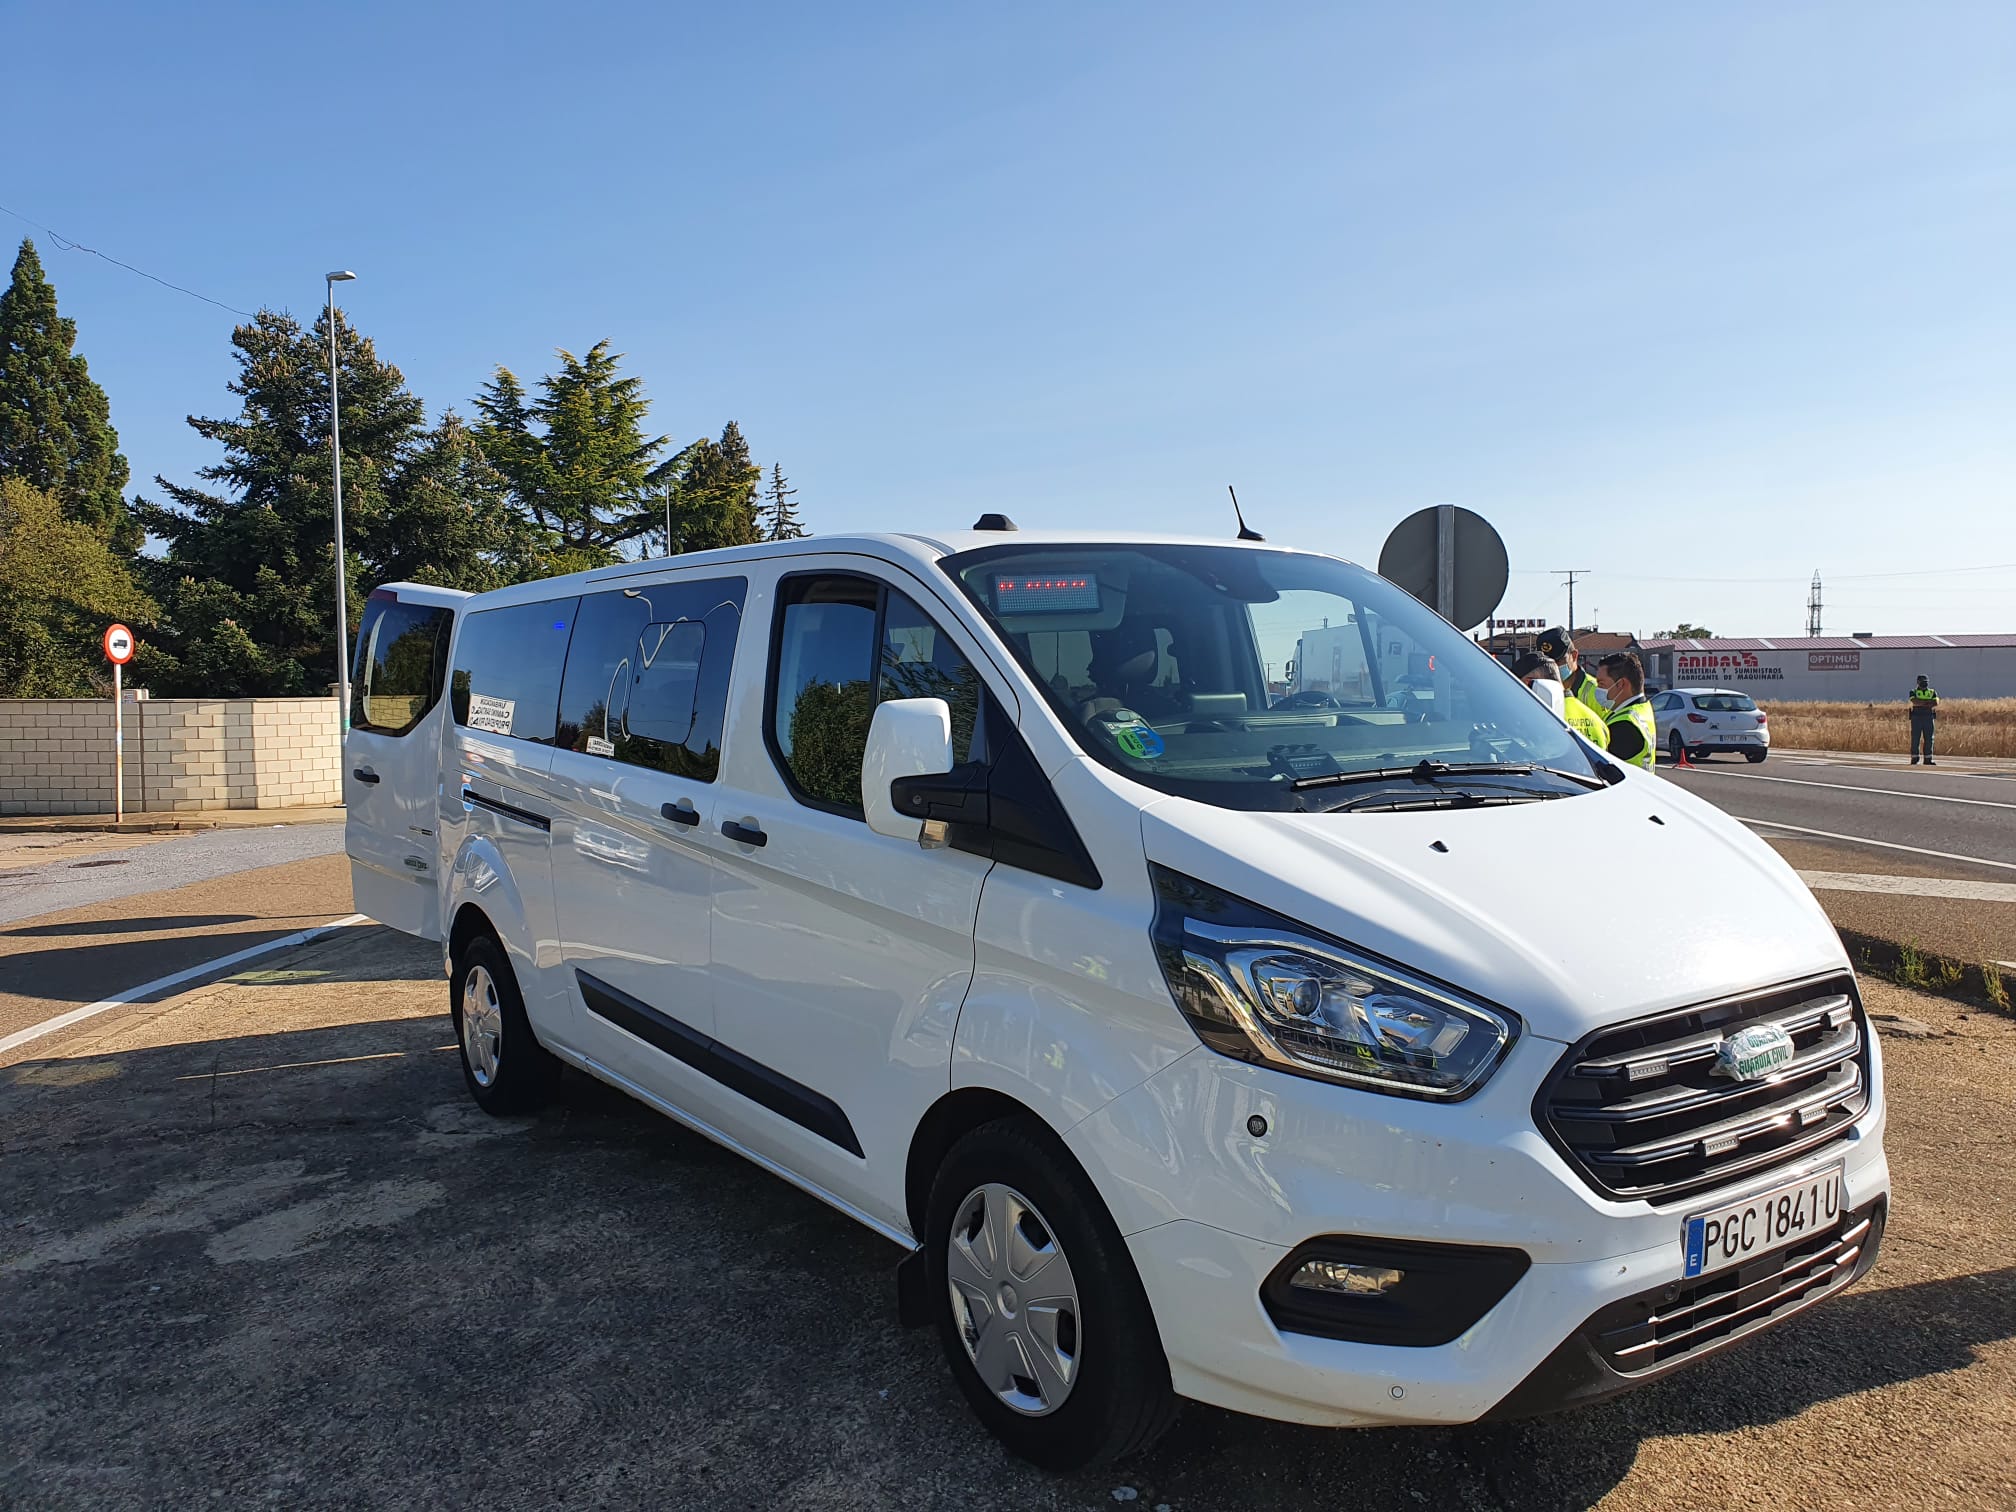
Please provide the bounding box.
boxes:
[925,1119,1177,1470]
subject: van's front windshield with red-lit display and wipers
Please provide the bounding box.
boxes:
[941,544,1599,810]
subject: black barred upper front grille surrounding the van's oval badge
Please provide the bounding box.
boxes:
[1534,976,1869,1208]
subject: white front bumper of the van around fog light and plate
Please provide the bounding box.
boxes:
[1066,1040,1889,1425]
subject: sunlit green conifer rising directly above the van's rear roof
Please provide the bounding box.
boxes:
[476,341,683,571]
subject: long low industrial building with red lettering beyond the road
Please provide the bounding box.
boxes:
[1635,635,2016,704]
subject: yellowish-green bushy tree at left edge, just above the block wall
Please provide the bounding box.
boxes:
[0,478,155,698]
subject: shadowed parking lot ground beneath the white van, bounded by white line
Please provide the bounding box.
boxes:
[0,927,2016,1512]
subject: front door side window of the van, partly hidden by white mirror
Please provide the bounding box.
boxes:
[770,577,980,812]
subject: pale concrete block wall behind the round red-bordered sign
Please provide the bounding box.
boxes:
[0,698,343,814]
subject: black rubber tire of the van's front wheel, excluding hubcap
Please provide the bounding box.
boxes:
[923,1117,1179,1470]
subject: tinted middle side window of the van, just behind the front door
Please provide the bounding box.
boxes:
[558,577,748,782]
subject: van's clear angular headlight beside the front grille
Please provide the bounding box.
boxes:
[1149,865,1520,1101]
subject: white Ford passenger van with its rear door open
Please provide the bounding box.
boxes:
[345,516,1889,1468]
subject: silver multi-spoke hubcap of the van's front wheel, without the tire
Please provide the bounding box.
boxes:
[946,1181,1081,1417]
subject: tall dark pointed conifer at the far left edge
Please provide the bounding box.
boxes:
[0,240,141,552]
